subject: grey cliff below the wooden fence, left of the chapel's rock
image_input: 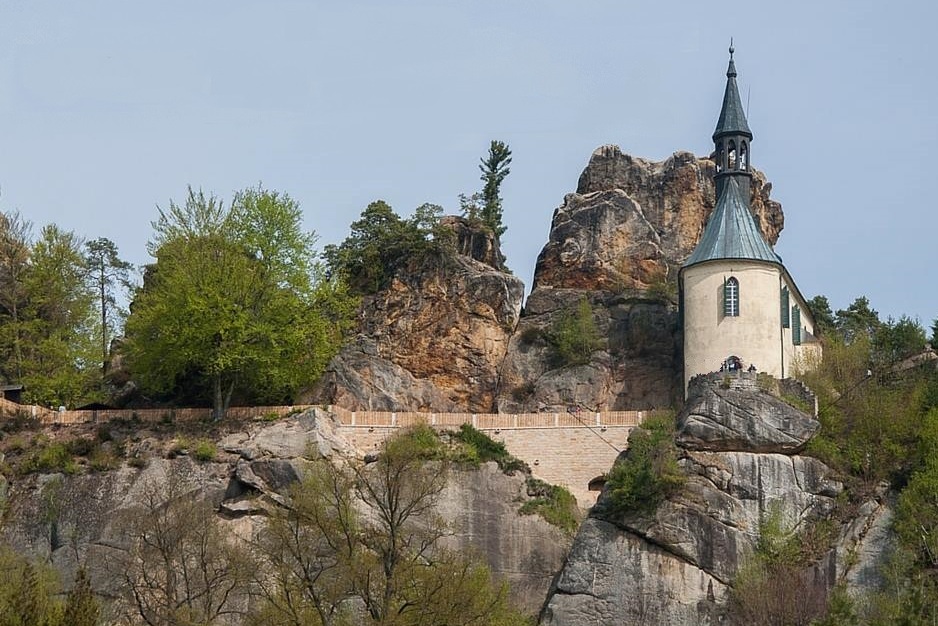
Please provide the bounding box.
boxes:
[0,410,570,614]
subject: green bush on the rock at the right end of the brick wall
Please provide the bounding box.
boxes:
[606,415,687,513]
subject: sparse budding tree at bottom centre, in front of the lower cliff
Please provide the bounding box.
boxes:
[254,426,524,626]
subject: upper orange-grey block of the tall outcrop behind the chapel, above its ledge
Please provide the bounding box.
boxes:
[534,145,784,291]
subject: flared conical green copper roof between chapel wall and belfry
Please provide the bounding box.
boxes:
[684,177,782,267]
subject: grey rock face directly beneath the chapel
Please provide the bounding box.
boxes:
[541,376,888,626]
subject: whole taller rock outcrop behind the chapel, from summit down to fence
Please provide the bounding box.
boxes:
[497,146,784,412]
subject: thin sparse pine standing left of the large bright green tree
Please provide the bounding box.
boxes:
[85,237,133,374]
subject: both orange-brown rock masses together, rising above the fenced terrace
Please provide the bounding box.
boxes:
[308,146,784,413]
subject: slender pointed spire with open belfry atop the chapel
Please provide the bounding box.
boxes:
[713,44,752,206]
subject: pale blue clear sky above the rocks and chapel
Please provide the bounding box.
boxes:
[0,0,938,326]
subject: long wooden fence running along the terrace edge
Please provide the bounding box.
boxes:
[0,398,653,430]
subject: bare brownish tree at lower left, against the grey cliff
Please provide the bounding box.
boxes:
[114,465,250,626]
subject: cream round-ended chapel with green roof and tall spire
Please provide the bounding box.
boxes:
[678,46,820,390]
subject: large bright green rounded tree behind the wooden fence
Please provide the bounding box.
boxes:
[126,187,353,419]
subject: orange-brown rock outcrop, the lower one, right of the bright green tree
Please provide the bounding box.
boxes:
[310,223,524,412]
